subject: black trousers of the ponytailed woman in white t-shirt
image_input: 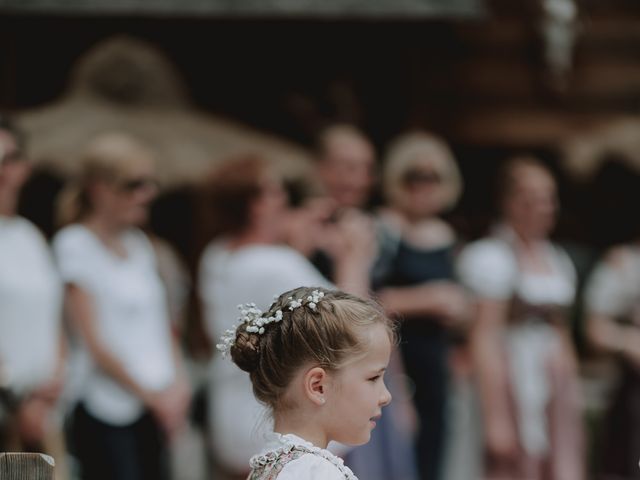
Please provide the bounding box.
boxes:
[69,404,169,480]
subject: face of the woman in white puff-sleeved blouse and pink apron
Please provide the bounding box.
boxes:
[504,165,558,239]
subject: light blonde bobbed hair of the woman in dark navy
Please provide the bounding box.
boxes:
[382,132,463,210]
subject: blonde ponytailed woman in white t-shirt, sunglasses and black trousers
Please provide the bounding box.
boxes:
[54,134,189,480]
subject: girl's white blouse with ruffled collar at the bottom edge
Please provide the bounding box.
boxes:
[251,432,358,480]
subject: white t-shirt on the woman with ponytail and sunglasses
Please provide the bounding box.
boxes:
[53,225,175,425]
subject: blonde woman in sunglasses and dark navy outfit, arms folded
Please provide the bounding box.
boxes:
[374,132,467,480]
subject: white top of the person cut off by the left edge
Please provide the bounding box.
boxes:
[0,216,62,393]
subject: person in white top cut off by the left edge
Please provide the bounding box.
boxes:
[0,118,64,453]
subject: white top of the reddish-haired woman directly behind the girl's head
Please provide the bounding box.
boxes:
[198,241,332,472]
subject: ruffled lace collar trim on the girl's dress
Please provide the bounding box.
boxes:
[247,434,358,480]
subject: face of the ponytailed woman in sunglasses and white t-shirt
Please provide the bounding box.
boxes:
[93,161,157,227]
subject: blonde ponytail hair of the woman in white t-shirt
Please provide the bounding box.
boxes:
[56,132,153,226]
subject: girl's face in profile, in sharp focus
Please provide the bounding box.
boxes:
[327,324,391,445]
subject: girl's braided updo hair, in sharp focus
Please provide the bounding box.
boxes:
[231,287,395,410]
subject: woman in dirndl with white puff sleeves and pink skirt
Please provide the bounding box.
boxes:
[459,158,584,480]
